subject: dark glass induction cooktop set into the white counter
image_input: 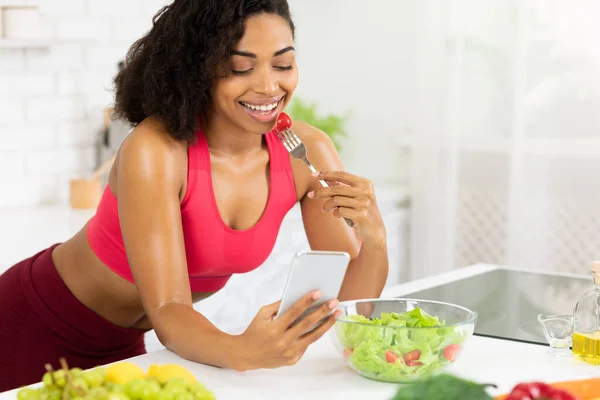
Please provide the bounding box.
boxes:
[399,269,592,345]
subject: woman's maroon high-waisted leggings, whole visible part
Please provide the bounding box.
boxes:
[0,245,146,392]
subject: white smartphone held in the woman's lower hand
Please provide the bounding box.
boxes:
[277,251,350,330]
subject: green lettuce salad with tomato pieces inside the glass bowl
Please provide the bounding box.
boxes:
[335,308,468,382]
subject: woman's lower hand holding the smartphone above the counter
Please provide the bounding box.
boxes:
[234,291,340,371]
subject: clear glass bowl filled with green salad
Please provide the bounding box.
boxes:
[333,299,477,383]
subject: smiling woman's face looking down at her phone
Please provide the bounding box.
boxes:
[212,14,298,134]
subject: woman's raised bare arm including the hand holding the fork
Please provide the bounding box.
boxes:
[293,122,388,301]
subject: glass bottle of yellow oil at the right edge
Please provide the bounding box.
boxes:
[572,261,600,365]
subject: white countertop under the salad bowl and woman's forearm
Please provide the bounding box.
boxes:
[0,265,600,400]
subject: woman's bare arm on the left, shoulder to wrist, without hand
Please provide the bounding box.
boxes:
[116,121,235,367]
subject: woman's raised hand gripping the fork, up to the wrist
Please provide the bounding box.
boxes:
[307,171,386,245]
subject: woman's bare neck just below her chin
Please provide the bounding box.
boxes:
[204,115,262,156]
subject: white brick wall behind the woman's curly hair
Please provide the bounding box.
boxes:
[0,0,159,207]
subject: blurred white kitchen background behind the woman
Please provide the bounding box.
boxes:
[0,0,600,349]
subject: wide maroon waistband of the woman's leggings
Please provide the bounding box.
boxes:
[21,244,146,356]
